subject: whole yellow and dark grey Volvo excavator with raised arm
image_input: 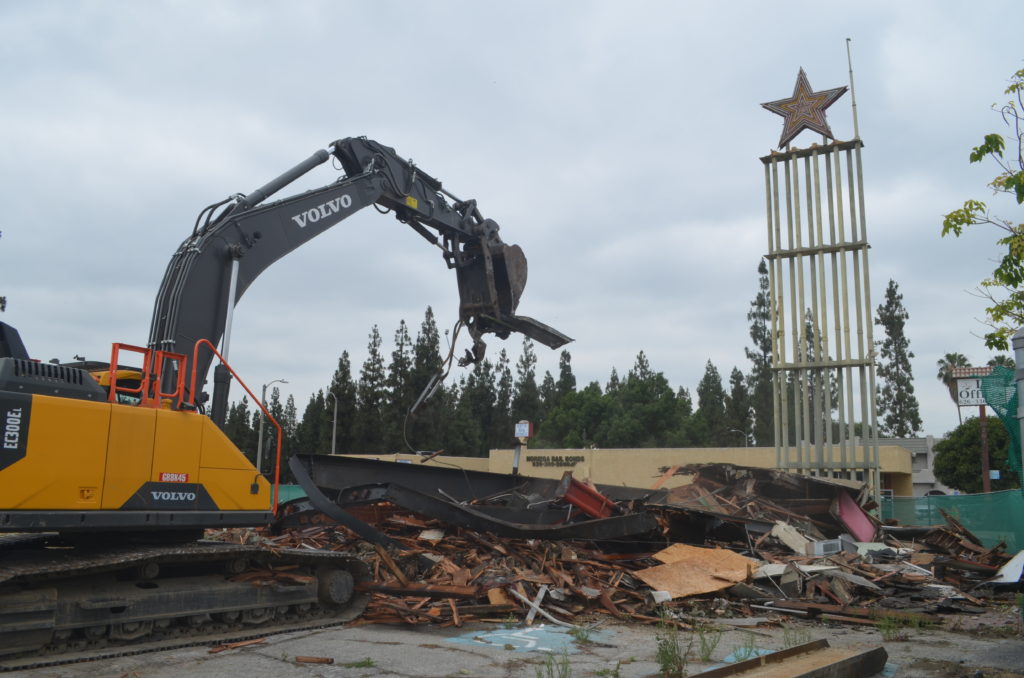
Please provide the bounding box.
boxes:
[0,137,570,669]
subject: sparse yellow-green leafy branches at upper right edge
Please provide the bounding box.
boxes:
[942,69,1024,350]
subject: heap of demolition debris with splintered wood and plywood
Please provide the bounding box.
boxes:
[211,464,1010,627]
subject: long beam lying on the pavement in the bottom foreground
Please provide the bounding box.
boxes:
[697,640,889,678]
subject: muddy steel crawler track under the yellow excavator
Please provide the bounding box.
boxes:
[0,535,370,671]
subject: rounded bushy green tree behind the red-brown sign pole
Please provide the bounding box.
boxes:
[933,417,1020,494]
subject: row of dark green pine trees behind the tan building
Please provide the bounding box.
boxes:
[225,262,921,477]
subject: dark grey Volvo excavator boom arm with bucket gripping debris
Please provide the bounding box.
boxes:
[148,137,571,422]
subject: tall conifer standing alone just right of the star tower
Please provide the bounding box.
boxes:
[874,280,922,438]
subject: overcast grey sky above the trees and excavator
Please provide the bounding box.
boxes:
[0,0,1024,435]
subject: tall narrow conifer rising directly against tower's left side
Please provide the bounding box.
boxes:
[743,259,775,444]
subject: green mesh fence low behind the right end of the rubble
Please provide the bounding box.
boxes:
[882,490,1024,553]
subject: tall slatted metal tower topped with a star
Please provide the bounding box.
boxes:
[761,69,881,498]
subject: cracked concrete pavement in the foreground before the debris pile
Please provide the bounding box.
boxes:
[8,611,1024,678]
